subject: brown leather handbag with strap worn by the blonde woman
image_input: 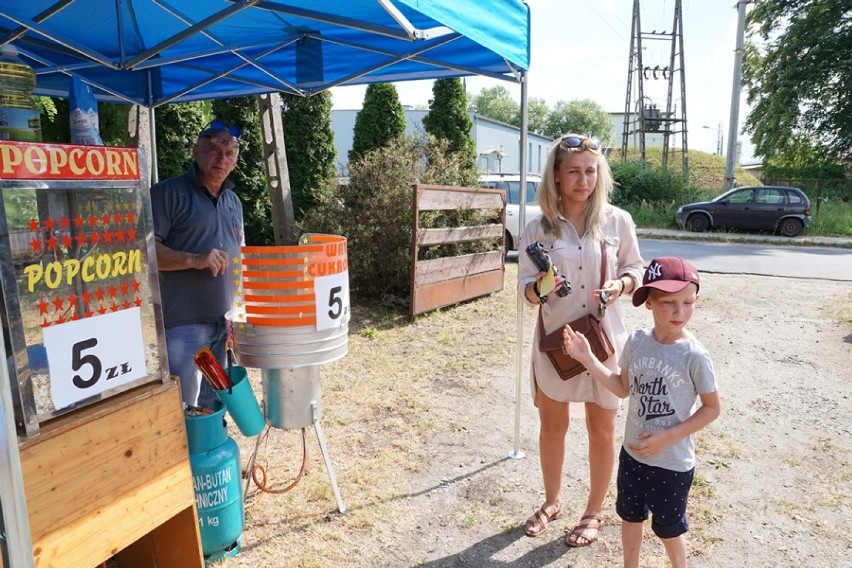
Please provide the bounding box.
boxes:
[538,241,615,381]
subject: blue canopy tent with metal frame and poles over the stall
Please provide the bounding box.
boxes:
[0,0,530,566]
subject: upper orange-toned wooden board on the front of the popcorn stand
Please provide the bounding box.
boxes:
[21,383,192,548]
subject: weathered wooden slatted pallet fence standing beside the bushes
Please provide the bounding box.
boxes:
[411,185,506,315]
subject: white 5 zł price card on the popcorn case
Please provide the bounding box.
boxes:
[43,308,147,409]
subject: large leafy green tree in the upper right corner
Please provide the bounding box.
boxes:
[743,0,852,164]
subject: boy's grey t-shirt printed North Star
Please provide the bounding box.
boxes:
[619,329,716,471]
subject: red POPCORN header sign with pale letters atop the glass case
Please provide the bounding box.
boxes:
[0,140,139,180]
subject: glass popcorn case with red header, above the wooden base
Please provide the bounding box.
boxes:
[0,141,168,437]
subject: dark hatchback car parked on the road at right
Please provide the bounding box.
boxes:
[675,186,811,237]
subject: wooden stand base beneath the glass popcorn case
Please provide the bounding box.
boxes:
[20,383,204,568]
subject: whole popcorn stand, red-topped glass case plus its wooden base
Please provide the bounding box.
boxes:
[0,140,203,567]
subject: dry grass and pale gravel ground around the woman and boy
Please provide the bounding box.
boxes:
[220,264,852,568]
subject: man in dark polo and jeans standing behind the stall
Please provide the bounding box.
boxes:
[151,120,245,408]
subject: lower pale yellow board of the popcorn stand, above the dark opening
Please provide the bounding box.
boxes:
[33,461,204,568]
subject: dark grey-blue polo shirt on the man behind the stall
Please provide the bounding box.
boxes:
[151,163,245,328]
